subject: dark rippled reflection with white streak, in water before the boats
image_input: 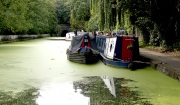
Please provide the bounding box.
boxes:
[73,76,152,105]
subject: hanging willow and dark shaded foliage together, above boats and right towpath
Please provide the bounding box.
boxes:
[89,0,180,49]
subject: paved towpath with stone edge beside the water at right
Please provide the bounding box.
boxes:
[140,48,180,81]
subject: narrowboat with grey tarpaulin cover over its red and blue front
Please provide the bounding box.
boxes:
[66,33,100,64]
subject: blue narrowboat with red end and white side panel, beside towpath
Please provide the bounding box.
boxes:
[96,35,139,69]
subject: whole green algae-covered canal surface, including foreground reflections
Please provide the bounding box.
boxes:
[0,38,180,105]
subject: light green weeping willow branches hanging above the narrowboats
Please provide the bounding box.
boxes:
[89,0,130,32]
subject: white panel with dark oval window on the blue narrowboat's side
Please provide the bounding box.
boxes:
[105,37,117,59]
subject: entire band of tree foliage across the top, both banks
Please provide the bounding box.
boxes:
[0,0,180,48]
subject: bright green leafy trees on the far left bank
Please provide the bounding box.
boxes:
[0,0,56,34]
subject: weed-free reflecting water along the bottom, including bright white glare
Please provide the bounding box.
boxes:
[0,76,152,105]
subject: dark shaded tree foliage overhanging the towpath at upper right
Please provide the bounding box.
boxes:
[127,0,180,48]
